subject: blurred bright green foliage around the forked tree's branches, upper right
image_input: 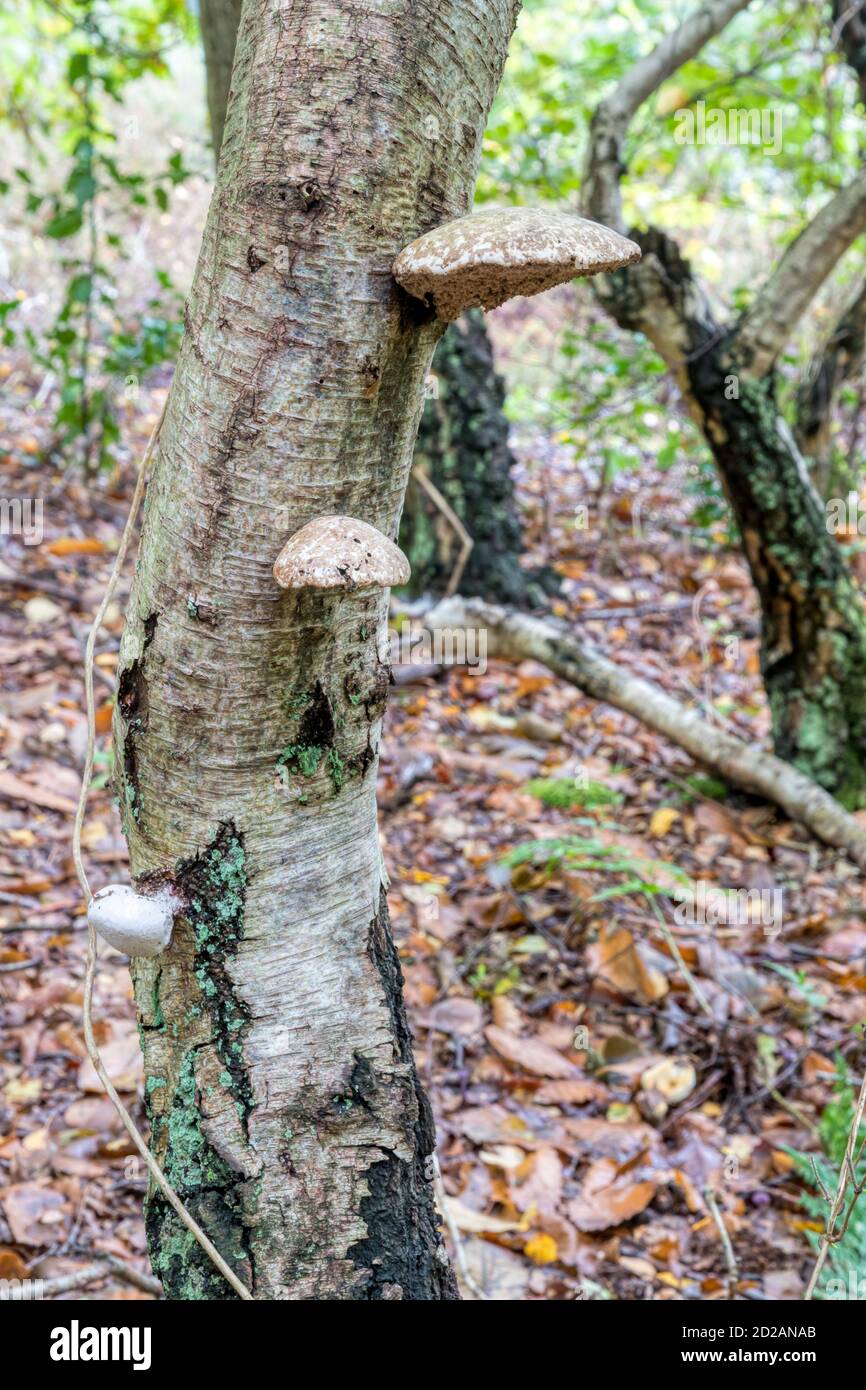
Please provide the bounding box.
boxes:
[477,0,862,497]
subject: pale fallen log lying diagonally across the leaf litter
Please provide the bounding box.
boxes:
[428,596,866,869]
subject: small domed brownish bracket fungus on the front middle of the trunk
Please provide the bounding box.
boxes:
[274,517,411,589]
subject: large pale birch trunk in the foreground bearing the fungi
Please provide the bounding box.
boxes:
[115,0,517,1300]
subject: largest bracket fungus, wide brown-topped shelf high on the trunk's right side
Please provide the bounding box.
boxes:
[393,207,641,322]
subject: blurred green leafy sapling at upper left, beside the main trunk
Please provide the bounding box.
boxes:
[0,0,190,471]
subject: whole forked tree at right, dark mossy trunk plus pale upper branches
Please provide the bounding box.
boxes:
[585,0,866,806]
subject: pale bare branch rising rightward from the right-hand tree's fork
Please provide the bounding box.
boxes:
[735,171,866,377]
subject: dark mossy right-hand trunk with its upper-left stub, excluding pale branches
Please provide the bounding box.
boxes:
[602,229,866,806]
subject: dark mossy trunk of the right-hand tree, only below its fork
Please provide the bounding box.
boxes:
[691,364,866,806]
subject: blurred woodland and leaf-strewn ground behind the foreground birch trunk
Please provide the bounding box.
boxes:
[0,0,866,1300]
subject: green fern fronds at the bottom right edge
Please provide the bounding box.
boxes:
[790,1055,866,1298]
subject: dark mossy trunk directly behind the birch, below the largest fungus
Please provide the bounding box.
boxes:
[400,309,550,605]
